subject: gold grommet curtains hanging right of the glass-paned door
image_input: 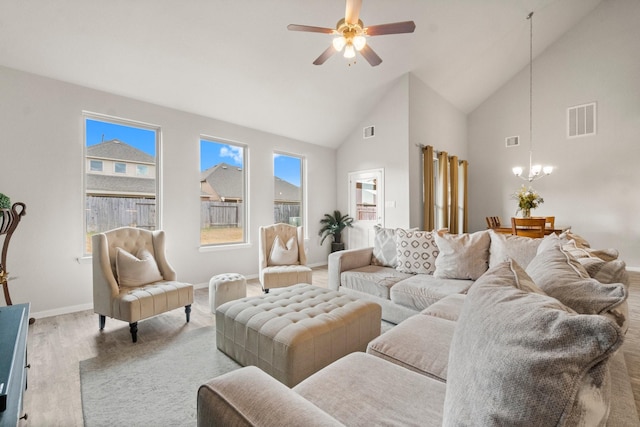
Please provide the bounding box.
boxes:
[422,145,469,233]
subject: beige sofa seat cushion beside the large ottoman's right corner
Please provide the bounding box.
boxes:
[367,314,456,381]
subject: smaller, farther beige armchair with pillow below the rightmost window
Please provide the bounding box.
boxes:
[259,223,311,292]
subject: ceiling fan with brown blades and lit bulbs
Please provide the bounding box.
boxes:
[287,0,416,67]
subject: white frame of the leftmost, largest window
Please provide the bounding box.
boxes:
[78,110,163,261]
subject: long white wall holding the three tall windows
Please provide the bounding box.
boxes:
[0,67,336,316]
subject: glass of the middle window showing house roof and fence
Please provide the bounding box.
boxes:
[200,138,247,246]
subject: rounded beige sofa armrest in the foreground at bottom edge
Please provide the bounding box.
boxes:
[198,366,342,427]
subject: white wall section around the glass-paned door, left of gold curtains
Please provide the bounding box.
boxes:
[337,74,467,236]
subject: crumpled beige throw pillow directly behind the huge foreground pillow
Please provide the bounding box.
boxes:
[526,239,627,314]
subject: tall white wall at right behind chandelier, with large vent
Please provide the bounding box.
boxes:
[469,0,640,267]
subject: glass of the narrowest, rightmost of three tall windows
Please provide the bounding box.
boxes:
[273,153,304,226]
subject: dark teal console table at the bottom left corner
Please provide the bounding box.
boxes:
[0,304,29,427]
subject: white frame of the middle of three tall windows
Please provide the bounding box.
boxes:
[198,134,251,247]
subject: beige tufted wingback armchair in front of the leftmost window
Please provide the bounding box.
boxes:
[92,227,193,342]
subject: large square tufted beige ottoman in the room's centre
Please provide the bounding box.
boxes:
[216,284,382,387]
